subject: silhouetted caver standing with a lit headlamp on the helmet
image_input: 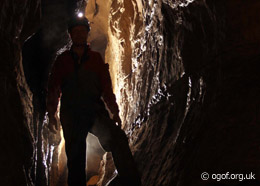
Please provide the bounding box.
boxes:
[47,17,141,186]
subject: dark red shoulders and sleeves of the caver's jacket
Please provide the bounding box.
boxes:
[47,47,119,115]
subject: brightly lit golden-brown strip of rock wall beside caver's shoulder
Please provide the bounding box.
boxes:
[106,0,144,128]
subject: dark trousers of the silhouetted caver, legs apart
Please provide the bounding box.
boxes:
[61,111,141,186]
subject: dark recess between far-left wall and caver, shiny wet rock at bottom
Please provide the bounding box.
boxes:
[22,1,71,185]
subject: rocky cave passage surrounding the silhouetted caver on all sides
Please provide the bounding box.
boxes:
[0,0,260,186]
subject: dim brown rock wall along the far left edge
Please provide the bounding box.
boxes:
[0,1,40,185]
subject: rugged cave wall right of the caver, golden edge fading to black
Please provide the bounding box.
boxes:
[107,0,260,186]
